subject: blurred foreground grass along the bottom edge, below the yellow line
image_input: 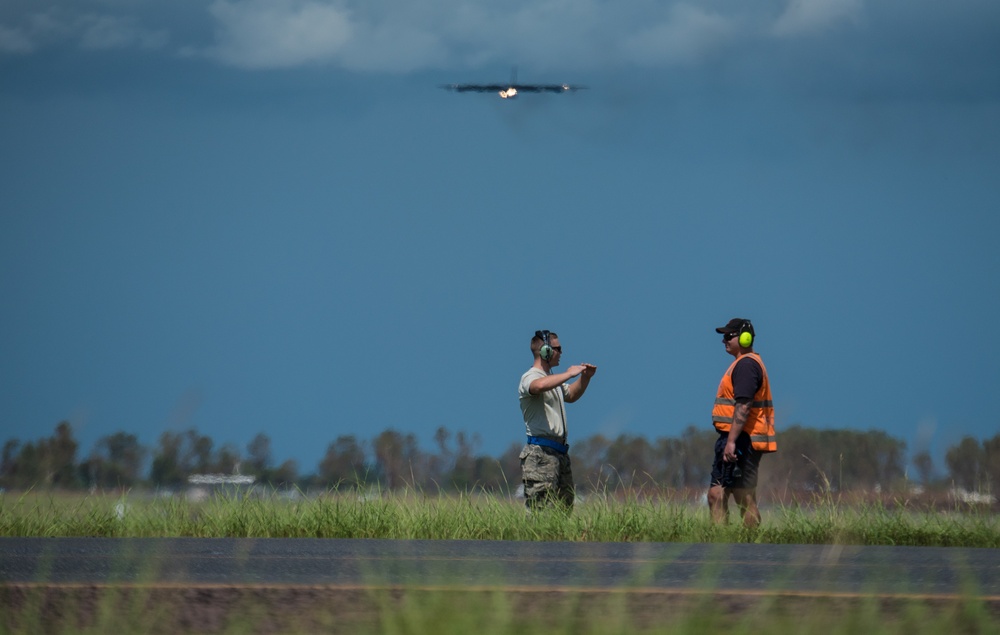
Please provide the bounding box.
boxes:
[0,587,1000,635]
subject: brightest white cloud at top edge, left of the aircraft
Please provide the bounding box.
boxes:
[206,0,354,68]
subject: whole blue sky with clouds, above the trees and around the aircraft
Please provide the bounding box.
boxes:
[0,0,1000,472]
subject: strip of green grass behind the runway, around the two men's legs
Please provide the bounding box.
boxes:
[0,492,1000,548]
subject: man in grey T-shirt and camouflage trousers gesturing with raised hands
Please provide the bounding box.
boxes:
[518,331,597,510]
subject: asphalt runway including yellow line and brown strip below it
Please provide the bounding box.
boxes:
[0,538,1000,632]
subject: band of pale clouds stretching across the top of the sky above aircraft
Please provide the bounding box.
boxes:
[0,0,1000,107]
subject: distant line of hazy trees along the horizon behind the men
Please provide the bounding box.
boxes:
[0,422,1000,494]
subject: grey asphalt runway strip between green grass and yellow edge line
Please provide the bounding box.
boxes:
[0,538,1000,599]
